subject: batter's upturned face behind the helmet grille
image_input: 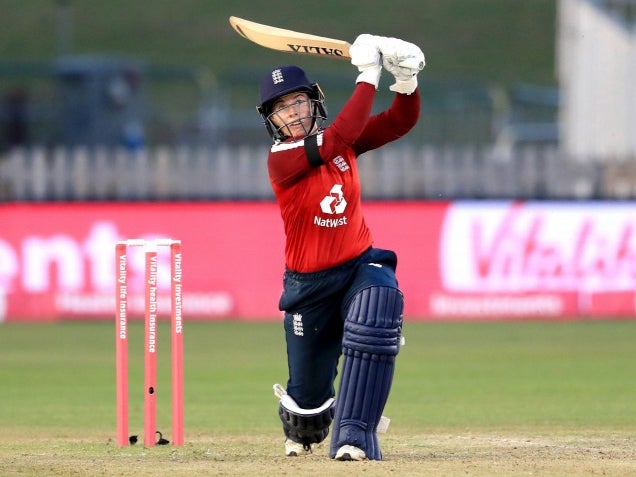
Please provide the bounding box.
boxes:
[271,92,313,140]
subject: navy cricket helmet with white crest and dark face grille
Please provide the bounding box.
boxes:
[256,65,327,140]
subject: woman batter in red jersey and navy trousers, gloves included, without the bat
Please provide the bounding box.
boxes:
[257,34,424,460]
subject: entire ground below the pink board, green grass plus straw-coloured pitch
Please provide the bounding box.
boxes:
[0,321,636,476]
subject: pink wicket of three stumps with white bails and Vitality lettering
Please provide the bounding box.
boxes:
[115,239,183,446]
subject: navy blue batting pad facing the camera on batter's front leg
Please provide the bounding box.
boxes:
[329,287,404,460]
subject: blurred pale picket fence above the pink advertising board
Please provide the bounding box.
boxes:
[0,145,636,201]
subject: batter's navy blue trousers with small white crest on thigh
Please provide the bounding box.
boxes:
[279,248,398,409]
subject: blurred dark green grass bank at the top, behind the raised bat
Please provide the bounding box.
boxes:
[0,0,556,87]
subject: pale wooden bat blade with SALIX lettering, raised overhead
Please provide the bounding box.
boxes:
[230,16,351,60]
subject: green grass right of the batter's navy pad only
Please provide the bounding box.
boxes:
[387,322,636,429]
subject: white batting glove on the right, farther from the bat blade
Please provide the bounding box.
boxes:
[379,38,426,94]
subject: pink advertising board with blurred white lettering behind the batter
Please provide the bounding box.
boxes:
[0,202,636,321]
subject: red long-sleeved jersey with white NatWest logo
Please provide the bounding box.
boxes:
[267,82,420,272]
